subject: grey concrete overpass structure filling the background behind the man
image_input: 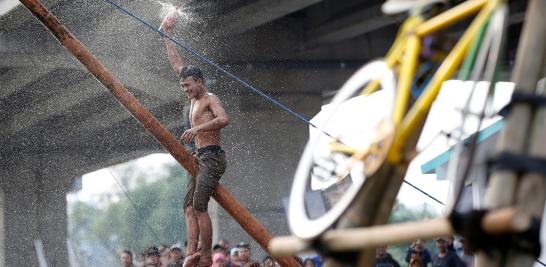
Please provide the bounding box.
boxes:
[0,0,525,266]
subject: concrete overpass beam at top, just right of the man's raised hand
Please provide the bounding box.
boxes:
[212,0,322,35]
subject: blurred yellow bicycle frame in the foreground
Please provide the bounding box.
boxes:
[363,0,501,164]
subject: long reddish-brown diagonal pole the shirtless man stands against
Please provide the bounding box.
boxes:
[19,0,298,266]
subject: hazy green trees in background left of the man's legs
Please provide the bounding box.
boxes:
[68,163,186,265]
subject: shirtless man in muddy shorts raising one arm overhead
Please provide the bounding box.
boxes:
[161,13,229,266]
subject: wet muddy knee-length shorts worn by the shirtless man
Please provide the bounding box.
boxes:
[184,146,226,212]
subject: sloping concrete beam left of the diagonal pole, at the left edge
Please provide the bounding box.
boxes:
[8,77,105,134]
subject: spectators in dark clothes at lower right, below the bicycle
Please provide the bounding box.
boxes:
[373,237,474,267]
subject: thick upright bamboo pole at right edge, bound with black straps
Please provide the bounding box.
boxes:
[476,0,546,267]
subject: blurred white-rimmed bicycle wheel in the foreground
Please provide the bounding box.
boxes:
[288,61,395,239]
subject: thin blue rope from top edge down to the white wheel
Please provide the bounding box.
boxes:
[101,0,340,142]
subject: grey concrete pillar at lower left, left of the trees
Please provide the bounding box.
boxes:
[0,157,68,266]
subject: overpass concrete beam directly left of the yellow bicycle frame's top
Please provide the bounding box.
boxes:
[307,5,396,44]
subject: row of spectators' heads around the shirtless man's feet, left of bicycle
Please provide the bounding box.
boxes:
[120,239,322,267]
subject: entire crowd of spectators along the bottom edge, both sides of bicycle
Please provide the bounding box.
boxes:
[120,237,473,267]
